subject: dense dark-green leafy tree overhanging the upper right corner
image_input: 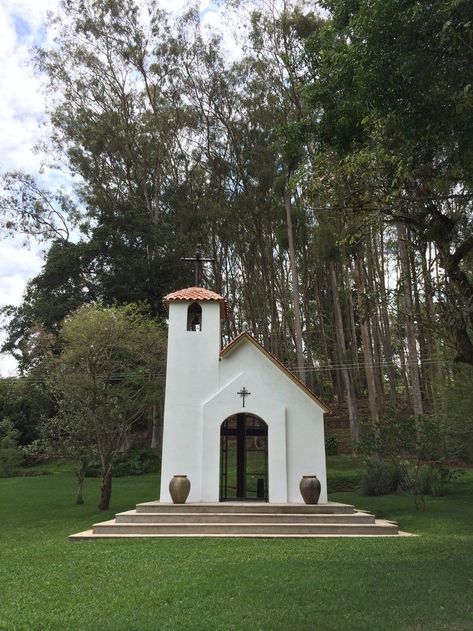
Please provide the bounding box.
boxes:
[306,0,473,364]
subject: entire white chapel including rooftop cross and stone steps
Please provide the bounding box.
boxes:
[69,276,406,541]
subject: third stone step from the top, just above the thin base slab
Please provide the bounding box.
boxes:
[89,519,398,538]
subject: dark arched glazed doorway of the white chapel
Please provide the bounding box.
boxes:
[220,414,268,502]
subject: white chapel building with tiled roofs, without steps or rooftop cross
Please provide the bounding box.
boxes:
[160,287,328,503]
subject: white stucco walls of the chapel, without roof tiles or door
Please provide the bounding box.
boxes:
[160,301,327,503]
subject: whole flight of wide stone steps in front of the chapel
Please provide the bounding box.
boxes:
[69,501,404,541]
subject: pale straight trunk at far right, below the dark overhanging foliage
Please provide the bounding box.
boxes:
[397,224,423,416]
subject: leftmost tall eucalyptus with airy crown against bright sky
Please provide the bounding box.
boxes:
[37,0,199,311]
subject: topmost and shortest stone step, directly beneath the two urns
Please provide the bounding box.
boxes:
[136,501,355,514]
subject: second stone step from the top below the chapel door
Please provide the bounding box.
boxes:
[115,510,375,524]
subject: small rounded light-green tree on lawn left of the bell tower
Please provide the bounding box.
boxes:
[48,305,165,510]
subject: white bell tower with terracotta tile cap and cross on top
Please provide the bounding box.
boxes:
[160,249,227,502]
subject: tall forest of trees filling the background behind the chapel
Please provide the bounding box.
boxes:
[0,0,473,461]
